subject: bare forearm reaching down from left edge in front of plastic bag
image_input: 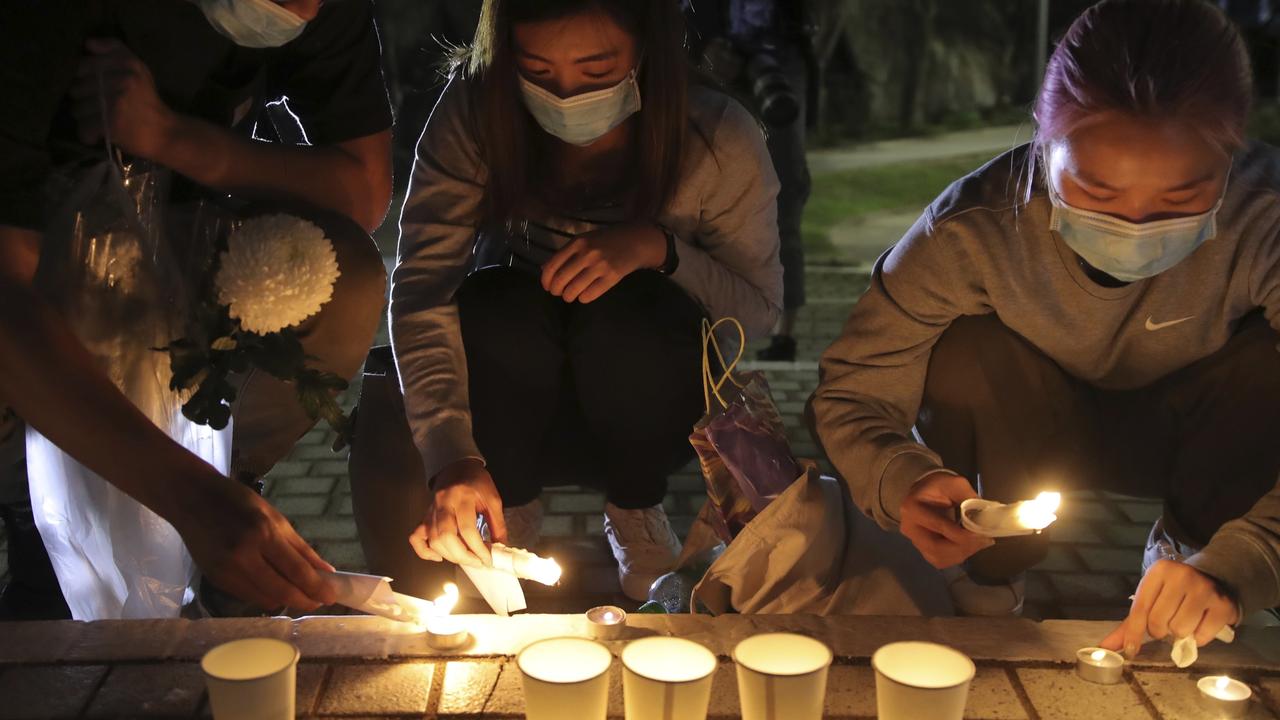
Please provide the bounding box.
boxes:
[0,274,216,518]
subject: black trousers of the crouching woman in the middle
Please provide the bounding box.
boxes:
[458,268,703,509]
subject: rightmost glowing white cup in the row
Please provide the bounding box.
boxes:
[872,642,977,720]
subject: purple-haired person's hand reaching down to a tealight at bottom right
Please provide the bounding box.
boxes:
[1102,560,1239,657]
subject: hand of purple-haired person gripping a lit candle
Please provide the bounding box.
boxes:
[900,470,995,568]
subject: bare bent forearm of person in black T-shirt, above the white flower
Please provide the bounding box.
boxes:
[154,115,390,232]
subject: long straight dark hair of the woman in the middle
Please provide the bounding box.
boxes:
[458,0,691,223]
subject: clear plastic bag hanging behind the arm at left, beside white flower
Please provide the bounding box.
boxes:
[27,158,232,620]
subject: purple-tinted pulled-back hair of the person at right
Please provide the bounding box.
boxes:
[1034,0,1253,152]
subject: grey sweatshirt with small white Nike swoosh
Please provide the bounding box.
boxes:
[810,145,1280,611]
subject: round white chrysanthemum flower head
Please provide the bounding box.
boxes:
[216,214,340,334]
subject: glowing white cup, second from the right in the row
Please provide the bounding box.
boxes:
[733,633,832,720]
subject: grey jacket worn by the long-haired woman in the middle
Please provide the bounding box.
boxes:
[390,78,782,489]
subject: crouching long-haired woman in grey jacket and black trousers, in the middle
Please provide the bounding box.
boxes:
[390,0,782,598]
